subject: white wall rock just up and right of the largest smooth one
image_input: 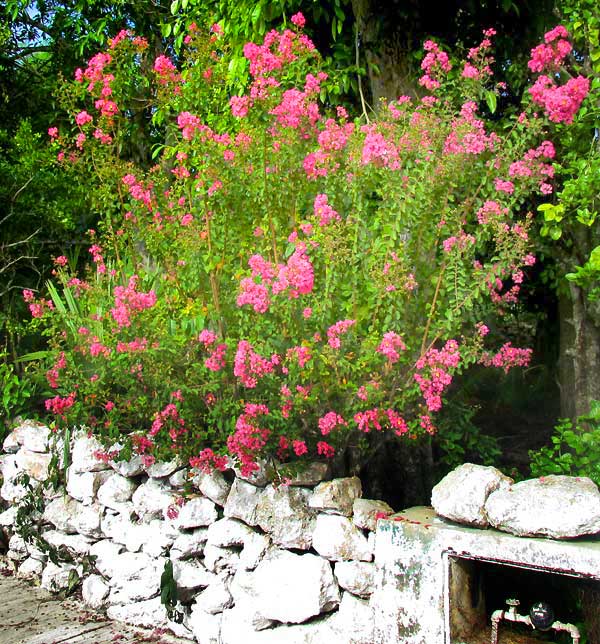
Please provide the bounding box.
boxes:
[313,514,373,561]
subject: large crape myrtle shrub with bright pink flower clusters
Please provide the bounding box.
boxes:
[24,14,588,474]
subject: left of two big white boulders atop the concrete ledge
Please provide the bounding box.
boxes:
[431,463,512,528]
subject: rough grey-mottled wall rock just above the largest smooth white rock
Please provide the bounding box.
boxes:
[256,485,315,550]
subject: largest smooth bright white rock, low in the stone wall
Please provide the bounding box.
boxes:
[251,550,339,624]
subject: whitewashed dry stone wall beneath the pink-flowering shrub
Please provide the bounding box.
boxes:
[0,422,392,644]
